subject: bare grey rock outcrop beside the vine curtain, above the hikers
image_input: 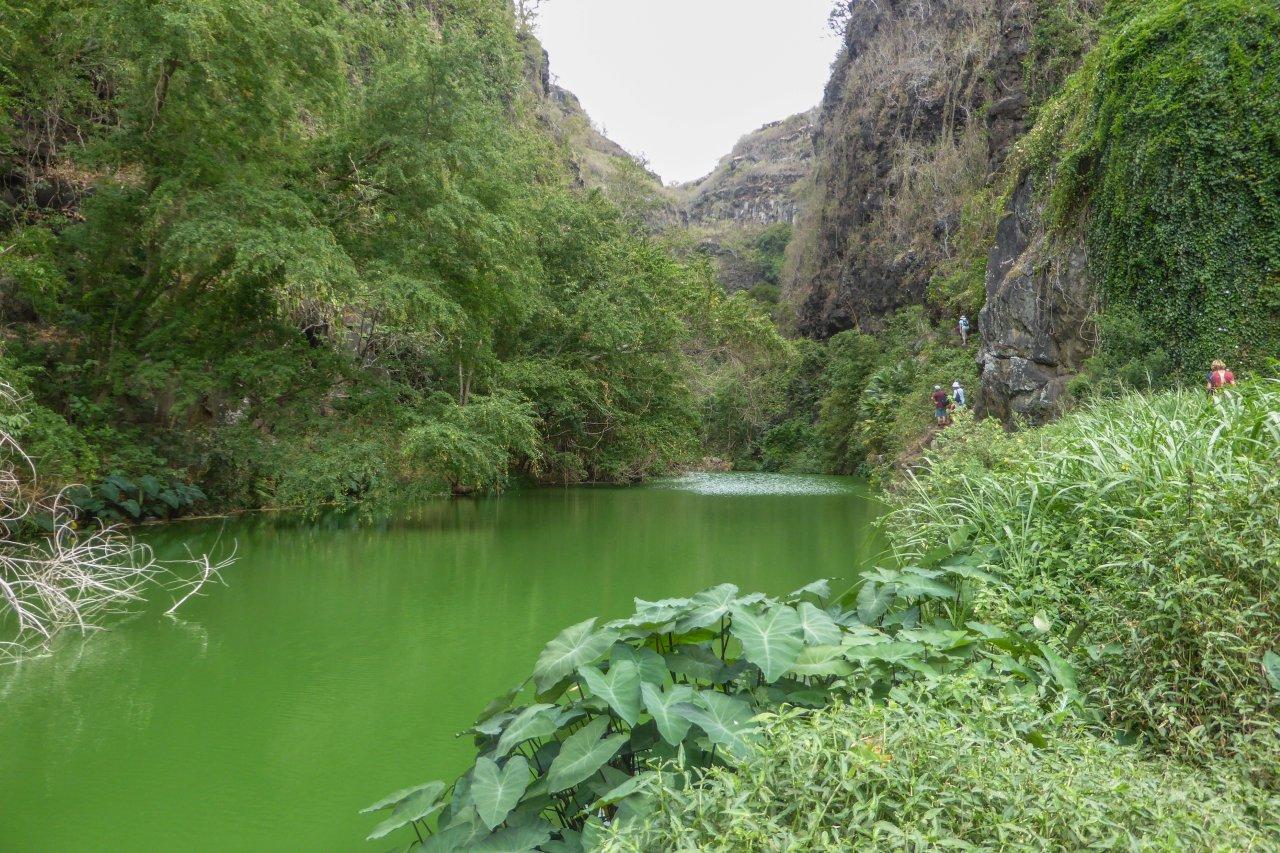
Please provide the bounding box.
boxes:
[978,179,1096,423]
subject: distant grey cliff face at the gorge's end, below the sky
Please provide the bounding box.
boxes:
[676,110,818,225]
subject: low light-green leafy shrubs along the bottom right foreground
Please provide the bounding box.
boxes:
[604,679,1280,852]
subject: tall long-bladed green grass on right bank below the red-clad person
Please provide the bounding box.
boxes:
[887,380,1280,788]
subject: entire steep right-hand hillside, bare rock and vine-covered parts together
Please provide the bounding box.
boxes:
[787,0,1280,421]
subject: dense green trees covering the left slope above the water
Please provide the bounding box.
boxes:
[0,0,767,516]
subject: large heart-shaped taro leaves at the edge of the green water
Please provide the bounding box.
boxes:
[366,560,1079,850]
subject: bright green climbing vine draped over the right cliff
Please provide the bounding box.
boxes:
[1024,0,1280,378]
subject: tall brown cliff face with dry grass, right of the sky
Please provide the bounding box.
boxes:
[790,0,1025,337]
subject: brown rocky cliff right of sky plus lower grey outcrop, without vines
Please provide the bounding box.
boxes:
[787,0,1094,419]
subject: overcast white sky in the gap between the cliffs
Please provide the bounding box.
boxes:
[538,0,838,182]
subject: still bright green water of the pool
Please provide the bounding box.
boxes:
[0,474,876,850]
